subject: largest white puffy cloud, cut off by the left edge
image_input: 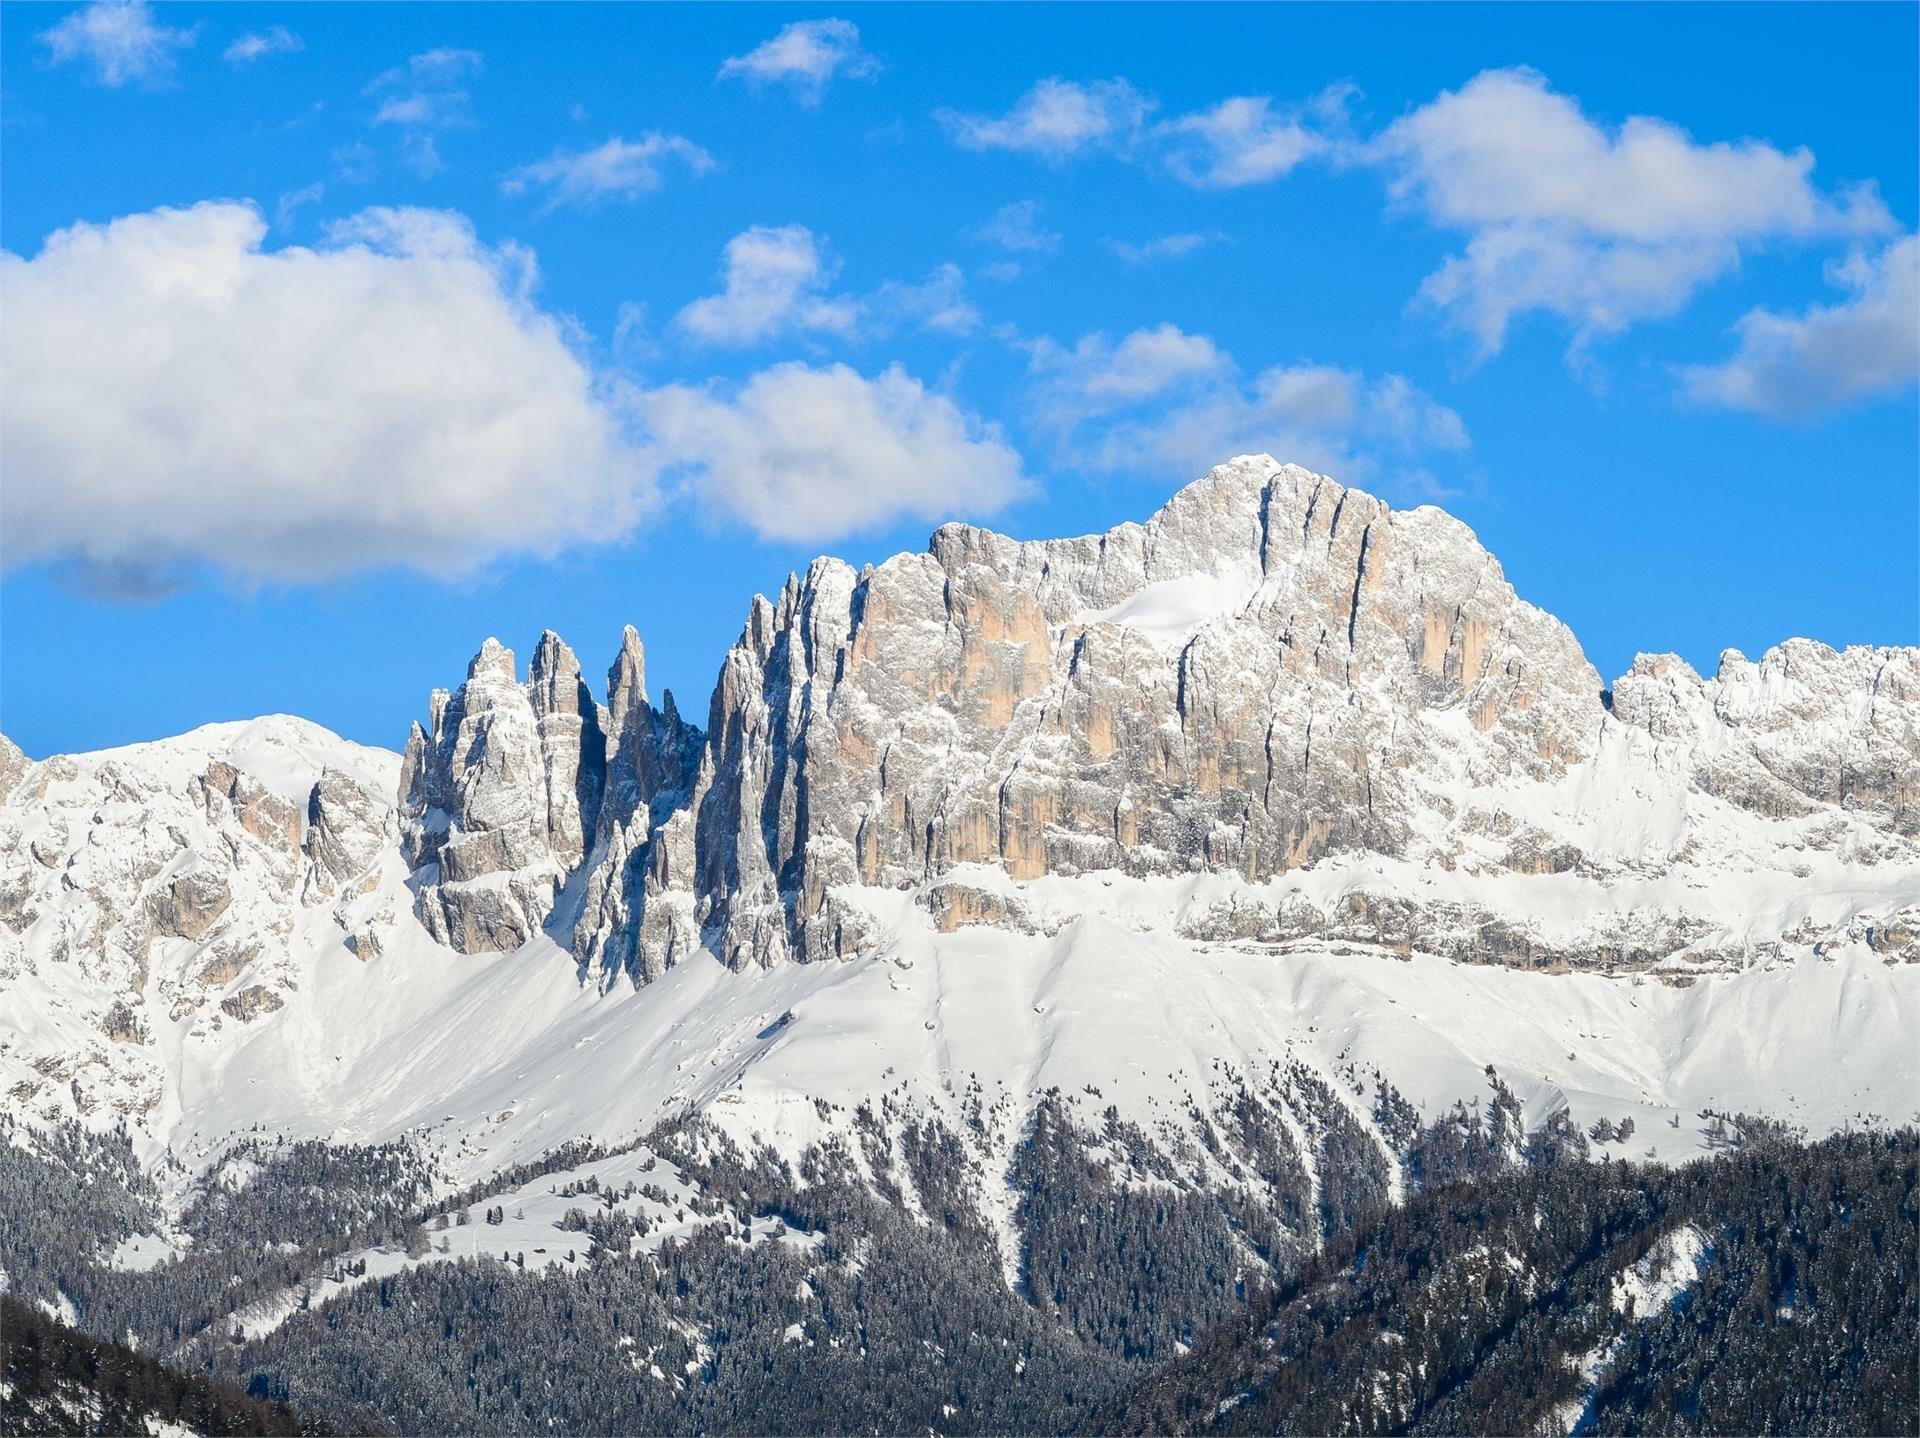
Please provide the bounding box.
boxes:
[0,202,649,593]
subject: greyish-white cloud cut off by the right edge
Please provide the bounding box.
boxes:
[1682,234,1920,417]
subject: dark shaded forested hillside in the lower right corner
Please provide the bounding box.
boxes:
[1096,1131,1920,1434]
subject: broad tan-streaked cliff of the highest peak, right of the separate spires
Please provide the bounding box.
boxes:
[675,457,1605,962]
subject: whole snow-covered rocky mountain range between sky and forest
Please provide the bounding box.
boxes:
[0,457,1920,1181]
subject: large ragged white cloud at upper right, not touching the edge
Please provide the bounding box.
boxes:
[1365,69,1891,353]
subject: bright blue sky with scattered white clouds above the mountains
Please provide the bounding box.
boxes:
[0,4,1920,755]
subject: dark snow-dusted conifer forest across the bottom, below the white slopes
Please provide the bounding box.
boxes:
[0,1075,1920,1434]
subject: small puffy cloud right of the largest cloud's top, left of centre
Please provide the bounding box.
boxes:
[678,225,860,346]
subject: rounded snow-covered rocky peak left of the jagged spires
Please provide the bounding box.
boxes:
[0,714,397,1115]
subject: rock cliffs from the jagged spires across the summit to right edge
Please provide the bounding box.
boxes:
[401,457,1920,983]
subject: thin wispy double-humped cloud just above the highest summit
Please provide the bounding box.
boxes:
[1029,324,1469,499]
